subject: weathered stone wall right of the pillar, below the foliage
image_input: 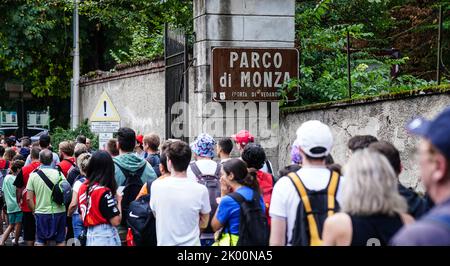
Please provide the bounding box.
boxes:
[278,92,450,191]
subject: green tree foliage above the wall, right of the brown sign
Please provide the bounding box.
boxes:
[288,0,450,105]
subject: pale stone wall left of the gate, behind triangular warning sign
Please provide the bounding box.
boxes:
[80,61,165,137]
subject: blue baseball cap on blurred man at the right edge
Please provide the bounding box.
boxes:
[406,108,450,159]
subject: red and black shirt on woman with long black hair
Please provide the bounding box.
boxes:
[78,181,120,227]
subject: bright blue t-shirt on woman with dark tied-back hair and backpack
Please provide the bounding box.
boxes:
[217,186,266,235]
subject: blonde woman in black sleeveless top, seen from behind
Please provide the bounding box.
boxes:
[323,150,414,246]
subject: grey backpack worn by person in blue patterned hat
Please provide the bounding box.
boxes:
[190,162,221,234]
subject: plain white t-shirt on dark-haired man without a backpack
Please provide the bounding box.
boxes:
[150,177,211,246]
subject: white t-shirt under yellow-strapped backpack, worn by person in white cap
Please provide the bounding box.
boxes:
[269,166,344,245]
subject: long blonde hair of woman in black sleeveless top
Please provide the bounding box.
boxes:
[342,149,407,216]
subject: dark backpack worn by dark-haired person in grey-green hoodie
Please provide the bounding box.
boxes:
[116,163,147,226]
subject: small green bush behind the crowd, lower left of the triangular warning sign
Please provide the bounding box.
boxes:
[51,119,98,150]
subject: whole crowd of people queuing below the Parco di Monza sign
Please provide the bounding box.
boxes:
[0,108,450,246]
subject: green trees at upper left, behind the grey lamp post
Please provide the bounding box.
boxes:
[0,0,192,98]
